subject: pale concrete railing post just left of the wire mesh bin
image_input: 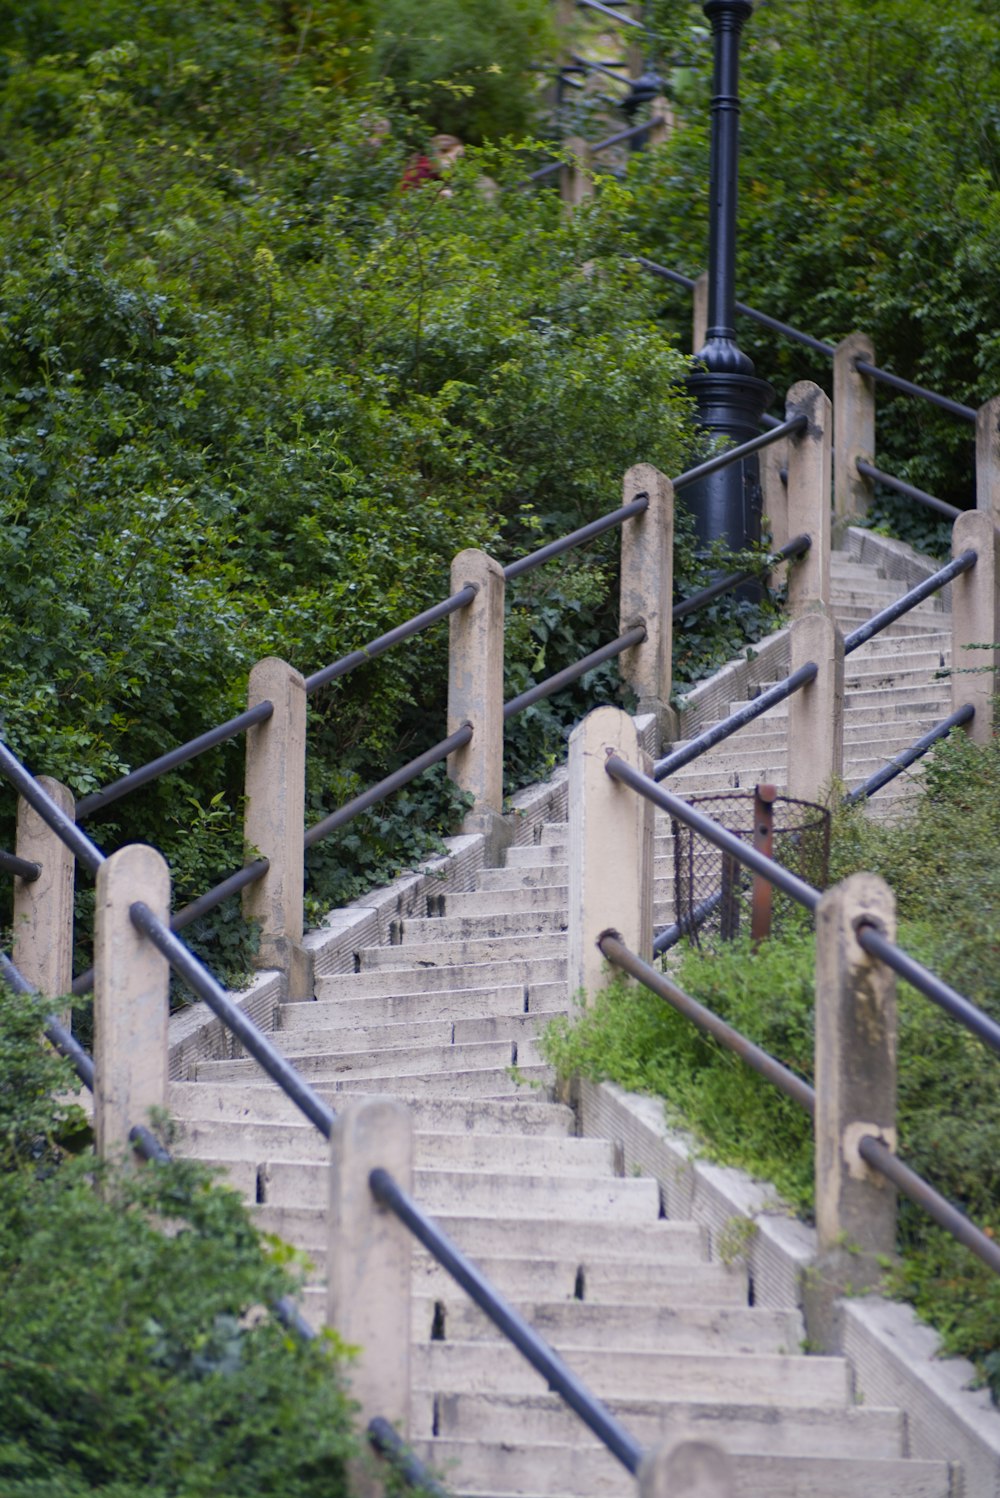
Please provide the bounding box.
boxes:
[569,707,653,1002]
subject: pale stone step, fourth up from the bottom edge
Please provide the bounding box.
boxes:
[419,1287,804,1356]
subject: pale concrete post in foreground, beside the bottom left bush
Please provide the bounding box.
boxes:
[326,1098,413,1437]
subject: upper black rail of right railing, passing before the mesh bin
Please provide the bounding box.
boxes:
[605,755,1000,1055]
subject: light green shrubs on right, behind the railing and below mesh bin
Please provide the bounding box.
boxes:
[543,734,1000,1401]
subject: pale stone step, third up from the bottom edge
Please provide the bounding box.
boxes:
[412,1342,850,1410]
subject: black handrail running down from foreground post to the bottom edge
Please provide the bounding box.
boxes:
[368,1170,644,1474]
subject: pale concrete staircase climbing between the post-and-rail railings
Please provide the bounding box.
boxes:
[171,545,957,1498]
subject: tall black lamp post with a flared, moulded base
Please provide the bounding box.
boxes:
[686,0,774,550]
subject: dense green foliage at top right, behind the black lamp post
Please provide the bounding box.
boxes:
[632,0,1000,550]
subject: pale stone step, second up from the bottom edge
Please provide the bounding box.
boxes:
[422,1389,904,1459]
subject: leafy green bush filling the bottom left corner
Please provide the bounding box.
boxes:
[0,993,363,1498]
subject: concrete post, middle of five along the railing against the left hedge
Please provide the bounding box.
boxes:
[448,550,507,863]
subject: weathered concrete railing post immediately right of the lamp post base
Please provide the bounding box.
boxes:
[786,380,831,619]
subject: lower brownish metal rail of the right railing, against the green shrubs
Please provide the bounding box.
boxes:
[597,932,1000,1273]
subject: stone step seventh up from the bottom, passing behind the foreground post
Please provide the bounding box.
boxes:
[202,1155,660,1216]
